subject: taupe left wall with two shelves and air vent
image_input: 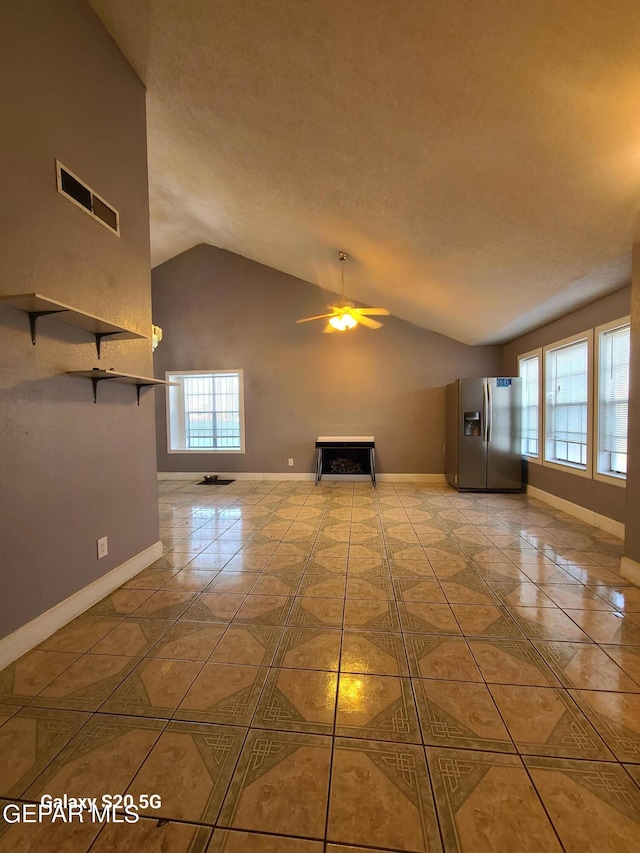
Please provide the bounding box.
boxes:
[0,0,158,636]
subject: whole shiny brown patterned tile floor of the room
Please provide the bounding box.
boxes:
[0,481,640,853]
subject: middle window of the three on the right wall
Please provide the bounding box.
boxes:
[544,331,592,477]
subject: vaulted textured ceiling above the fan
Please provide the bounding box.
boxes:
[91,0,640,343]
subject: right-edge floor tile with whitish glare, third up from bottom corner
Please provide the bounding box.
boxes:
[534,640,640,693]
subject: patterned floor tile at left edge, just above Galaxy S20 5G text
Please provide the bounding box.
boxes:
[0,708,89,797]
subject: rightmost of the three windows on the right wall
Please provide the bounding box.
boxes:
[596,317,631,485]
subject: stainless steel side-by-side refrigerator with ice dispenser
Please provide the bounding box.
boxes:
[445,376,522,492]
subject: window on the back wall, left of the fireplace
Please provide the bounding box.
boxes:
[166,370,244,453]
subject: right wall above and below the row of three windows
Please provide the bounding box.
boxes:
[504,287,637,522]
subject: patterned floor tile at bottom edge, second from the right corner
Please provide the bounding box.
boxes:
[427,747,560,853]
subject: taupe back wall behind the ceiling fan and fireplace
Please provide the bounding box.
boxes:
[152,245,502,474]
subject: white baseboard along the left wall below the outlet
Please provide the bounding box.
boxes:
[0,542,162,669]
